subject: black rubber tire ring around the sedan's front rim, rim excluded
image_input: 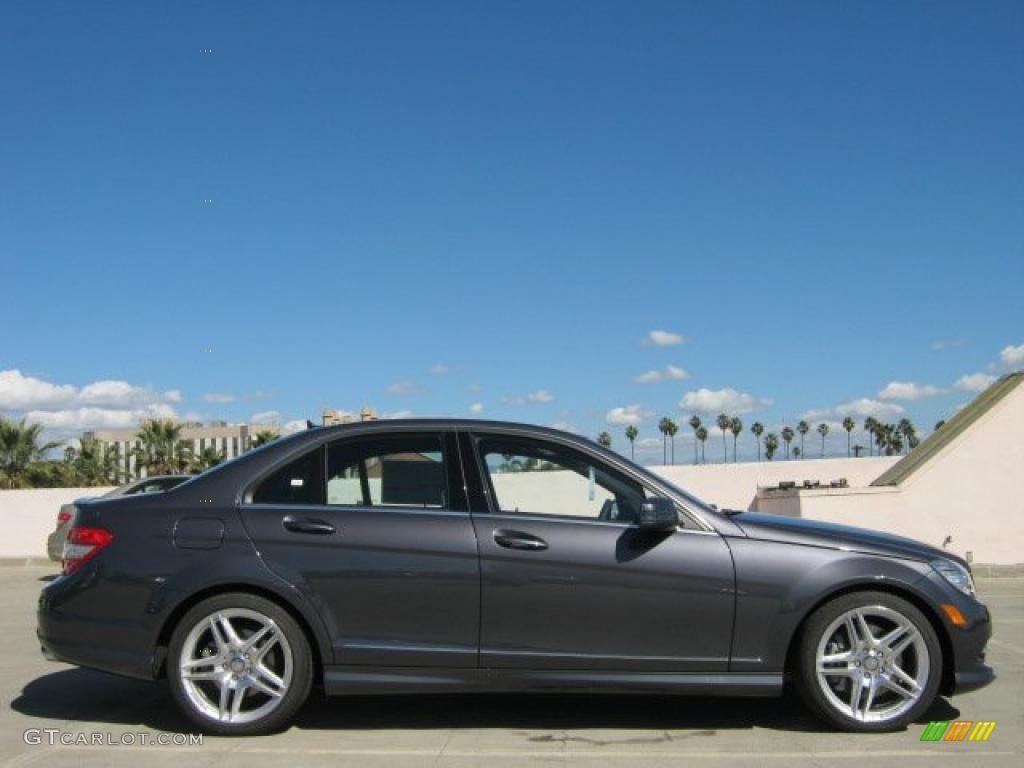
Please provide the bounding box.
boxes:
[796,591,943,732]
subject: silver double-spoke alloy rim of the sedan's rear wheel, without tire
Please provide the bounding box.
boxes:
[177,608,294,724]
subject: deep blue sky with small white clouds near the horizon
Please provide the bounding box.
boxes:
[0,0,1024,456]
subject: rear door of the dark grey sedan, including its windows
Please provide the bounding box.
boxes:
[242,430,479,667]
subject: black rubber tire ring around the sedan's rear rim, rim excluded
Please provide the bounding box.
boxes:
[167,592,313,736]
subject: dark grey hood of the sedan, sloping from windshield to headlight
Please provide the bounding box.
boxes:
[732,512,967,566]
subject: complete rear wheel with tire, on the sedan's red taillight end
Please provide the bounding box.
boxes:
[167,592,313,736]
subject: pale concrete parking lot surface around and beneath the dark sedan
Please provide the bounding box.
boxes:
[0,566,1024,768]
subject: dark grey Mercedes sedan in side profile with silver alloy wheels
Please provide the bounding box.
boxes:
[38,420,993,734]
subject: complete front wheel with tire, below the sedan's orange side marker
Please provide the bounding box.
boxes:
[795,592,942,732]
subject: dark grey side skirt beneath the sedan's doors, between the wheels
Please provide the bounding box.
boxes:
[324,667,782,696]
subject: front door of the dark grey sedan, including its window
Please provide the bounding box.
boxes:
[462,432,734,672]
